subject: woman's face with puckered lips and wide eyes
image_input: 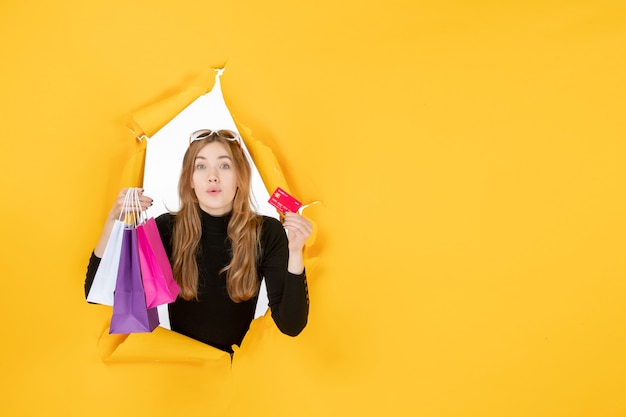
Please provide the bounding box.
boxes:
[191,142,237,216]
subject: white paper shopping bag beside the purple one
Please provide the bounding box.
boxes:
[87,220,125,306]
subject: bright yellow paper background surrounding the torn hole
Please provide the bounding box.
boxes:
[0,0,626,417]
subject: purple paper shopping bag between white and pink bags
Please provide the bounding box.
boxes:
[109,227,159,334]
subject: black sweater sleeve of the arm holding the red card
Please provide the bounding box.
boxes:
[260,217,309,336]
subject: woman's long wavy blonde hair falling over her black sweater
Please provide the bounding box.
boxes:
[172,130,262,302]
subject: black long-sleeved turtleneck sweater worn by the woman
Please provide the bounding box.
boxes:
[85,210,309,352]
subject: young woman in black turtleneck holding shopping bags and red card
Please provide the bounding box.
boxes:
[85,130,312,353]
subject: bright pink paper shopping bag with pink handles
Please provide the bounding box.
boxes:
[137,217,180,308]
